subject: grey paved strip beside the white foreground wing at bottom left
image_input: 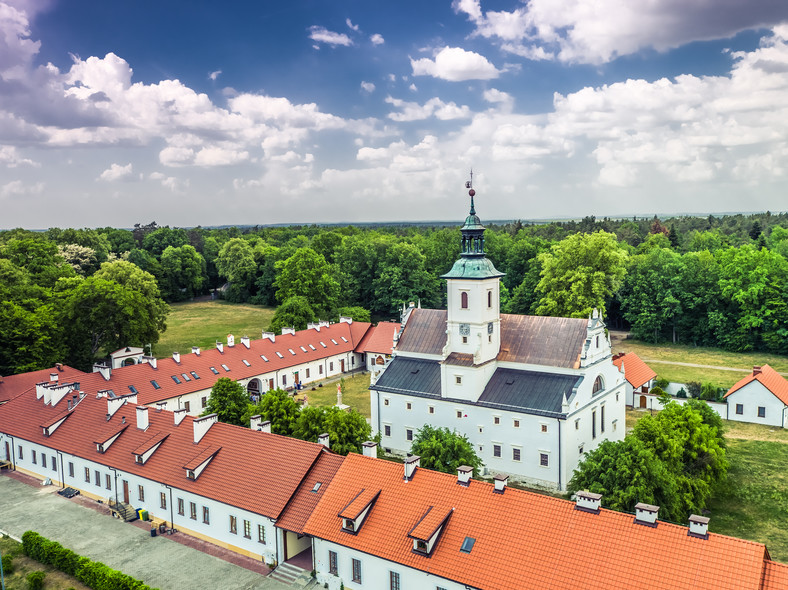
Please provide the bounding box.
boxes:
[0,474,288,590]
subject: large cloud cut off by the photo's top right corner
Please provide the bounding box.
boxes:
[452,0,788,64]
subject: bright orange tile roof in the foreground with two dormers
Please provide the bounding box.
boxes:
[304,454,783,590]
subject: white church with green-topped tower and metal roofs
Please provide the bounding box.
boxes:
[370,183,626,490]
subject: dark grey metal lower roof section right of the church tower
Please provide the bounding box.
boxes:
[478,369,583,414]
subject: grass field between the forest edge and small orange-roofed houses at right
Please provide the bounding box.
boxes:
[613,340,788,387]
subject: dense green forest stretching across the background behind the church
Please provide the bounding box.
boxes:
[0,212,788,375]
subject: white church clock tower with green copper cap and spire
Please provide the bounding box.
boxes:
[442,172,504,365]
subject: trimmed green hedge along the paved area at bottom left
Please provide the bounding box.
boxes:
[22,531,155,590]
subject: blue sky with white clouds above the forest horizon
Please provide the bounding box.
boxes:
[0,0,788,229]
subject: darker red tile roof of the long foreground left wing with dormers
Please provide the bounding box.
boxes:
[0,388,325,518]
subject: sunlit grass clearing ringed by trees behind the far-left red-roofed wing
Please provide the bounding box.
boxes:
[153,301,274,358]
